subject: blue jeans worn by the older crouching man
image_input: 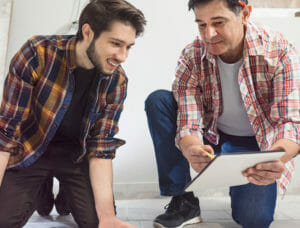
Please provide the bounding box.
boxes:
[145,90,277,228]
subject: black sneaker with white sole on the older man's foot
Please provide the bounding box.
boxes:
[153,192,201,228]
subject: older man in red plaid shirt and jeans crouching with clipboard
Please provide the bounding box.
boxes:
[146,0,300,228]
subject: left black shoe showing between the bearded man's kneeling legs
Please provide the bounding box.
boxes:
[37,176,54,216]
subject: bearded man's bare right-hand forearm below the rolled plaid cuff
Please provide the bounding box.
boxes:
[90,158,115,220]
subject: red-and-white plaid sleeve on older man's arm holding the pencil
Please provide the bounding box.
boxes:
[172,46,204,146]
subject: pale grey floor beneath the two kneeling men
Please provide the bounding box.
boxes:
[25,195,300,228]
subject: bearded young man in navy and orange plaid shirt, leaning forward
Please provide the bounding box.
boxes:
[0,0,145,228]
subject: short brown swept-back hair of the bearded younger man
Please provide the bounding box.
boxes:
[76,0,146,41]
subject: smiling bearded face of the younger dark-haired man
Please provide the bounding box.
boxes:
[86,21,136,75]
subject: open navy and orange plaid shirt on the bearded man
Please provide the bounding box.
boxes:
[0,36,127,168]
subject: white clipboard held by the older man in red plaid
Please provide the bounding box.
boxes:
[184,150,285,191]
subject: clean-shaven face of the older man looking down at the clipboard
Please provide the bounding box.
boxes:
[194,0,251,63]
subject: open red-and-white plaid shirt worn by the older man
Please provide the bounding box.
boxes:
[172,22,300,194]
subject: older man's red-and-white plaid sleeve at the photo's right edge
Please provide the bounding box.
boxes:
[270,43,300,145]
